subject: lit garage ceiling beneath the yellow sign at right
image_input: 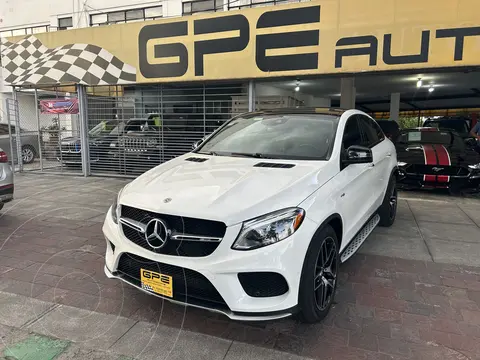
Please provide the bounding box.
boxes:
[260,69,480,111]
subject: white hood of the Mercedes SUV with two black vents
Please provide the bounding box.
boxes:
[120,154,334,225]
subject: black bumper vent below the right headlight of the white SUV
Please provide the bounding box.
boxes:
[238,272,288,297]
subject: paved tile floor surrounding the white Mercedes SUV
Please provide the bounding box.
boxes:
[0,175,480,360]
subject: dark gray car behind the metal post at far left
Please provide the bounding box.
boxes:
[0,124,39,164]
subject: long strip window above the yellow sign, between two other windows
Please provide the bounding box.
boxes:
[90,6,163,26]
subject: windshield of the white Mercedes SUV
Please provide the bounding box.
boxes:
[197,114,338,160]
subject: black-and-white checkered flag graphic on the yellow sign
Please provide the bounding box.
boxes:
[0,36,136,85]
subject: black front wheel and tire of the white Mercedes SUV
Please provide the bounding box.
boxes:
[298,225,340,323]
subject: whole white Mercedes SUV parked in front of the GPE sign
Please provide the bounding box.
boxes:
[103,108,397,322]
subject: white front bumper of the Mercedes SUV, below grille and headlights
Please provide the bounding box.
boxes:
[103,208,317,321]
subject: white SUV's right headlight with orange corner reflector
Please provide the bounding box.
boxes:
[232,208,305,250]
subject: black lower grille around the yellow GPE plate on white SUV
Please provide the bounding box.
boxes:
[117,253,229,310]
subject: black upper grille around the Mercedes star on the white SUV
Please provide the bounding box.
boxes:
[121,205,227,257]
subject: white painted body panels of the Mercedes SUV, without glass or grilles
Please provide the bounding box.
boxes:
[103,110,397,320]
